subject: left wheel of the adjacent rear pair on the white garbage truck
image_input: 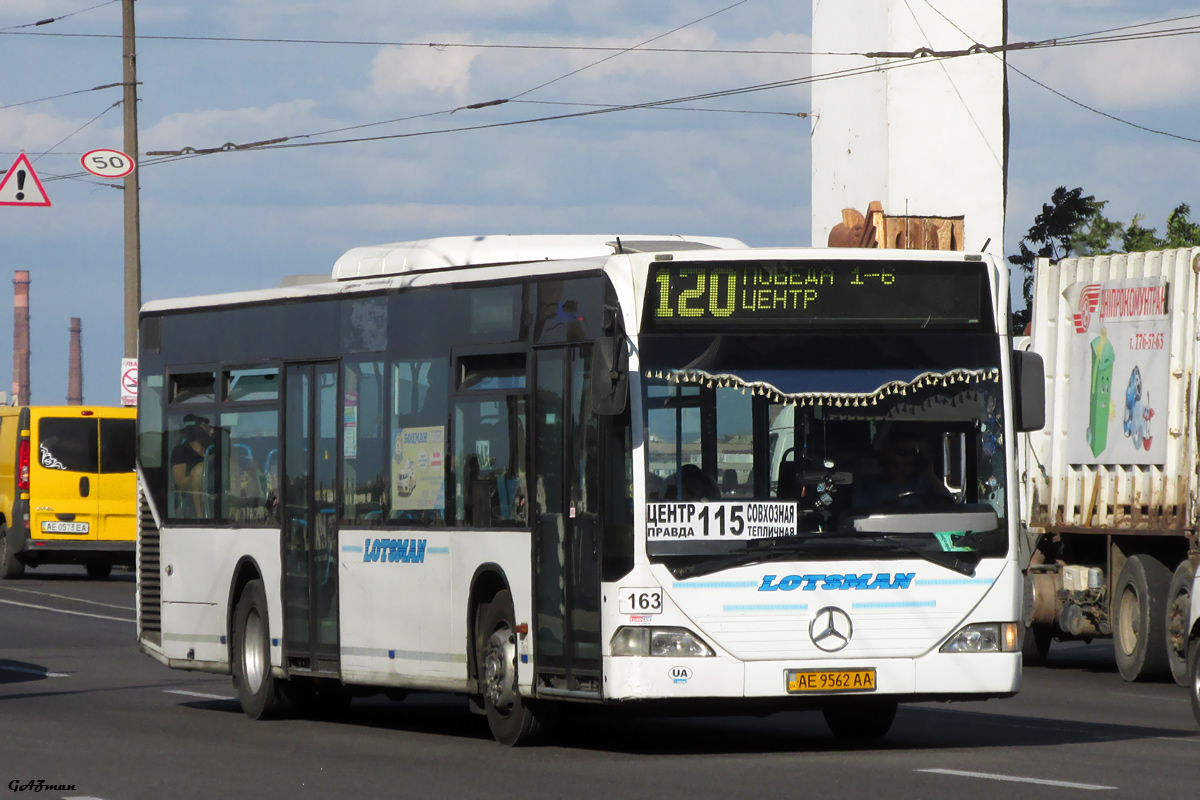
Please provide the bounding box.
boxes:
[1112,554,1171,680]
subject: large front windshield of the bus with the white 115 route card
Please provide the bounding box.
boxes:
[640,331,1007,563]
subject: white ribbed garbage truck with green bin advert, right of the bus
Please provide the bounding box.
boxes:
[1022,247,1200,700]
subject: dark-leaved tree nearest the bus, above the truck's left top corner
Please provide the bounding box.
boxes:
[1008,186,1104,331]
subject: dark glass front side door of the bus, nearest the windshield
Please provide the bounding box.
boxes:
[534,345,601,694]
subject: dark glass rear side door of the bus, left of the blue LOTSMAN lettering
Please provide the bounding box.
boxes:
[282,362,341,674]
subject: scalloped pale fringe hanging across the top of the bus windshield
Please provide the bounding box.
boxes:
[647,367,1000,408]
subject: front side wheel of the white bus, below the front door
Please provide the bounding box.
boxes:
[476,590,540,747]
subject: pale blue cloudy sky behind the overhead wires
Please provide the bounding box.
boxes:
[0,0,1200,404]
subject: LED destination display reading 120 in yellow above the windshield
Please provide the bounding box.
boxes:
[647,260,990,330]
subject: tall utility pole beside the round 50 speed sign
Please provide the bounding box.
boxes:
[121,0,142,359]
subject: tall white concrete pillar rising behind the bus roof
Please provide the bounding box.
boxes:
[812,0,1008,260]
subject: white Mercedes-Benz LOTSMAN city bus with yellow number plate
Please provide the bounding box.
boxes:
[138,236,1044,745]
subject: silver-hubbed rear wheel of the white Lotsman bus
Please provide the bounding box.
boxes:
[233,579,283,720]
